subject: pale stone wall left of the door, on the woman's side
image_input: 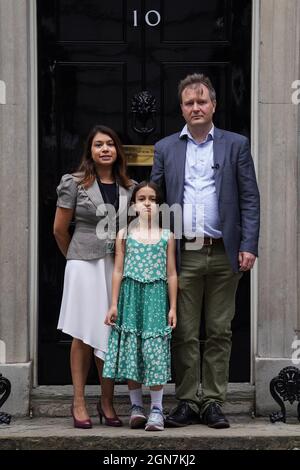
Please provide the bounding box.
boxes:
[0,0,30,413]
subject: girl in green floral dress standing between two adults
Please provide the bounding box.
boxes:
[103,181,177,431]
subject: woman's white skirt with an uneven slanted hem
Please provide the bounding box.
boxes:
[57,255,114,360]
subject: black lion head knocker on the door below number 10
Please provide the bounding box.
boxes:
[131,91,156,136]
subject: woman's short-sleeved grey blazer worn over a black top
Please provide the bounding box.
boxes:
[57,174,134,260]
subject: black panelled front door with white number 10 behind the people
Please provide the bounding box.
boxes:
[37,0,251,384]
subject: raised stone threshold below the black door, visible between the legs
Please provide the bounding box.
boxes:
[30,383,255,417]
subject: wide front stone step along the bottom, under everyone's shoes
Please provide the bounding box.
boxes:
[0,415,300,453]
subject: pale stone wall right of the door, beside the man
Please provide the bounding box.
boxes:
[255,0,300,414]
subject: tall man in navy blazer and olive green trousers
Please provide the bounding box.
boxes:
[151,74,259,428]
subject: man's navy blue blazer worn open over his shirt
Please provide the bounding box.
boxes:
[151,127,260,272]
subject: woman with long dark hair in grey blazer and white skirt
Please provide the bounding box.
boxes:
[54,125,133,428]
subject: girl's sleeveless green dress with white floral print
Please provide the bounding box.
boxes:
[103,230,172,386]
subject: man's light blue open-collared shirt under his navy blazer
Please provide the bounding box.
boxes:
[180,125,222,238]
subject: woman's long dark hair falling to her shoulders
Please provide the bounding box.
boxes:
[77,124,132,188]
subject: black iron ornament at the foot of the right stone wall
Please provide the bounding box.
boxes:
[270,367,300,423]
